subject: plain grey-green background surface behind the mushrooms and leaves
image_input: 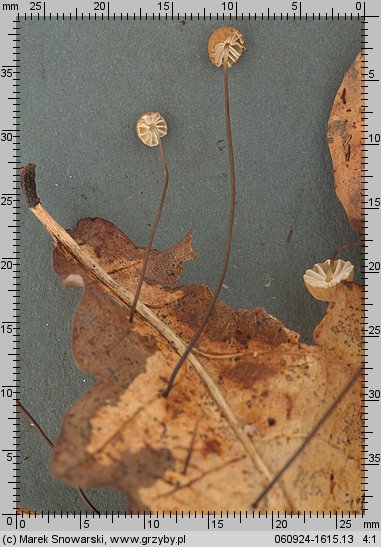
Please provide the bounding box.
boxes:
[20,21,361,511]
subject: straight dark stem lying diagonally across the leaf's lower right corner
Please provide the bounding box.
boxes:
[252,367,362,509]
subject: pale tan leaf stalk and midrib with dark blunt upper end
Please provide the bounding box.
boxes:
[20,164,291,507]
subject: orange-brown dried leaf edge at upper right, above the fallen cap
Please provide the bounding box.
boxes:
[328,52,364,235]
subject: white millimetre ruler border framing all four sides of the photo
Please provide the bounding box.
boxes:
[0,0,381,544]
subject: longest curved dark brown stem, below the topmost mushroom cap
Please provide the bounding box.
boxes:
[163,46,236,397]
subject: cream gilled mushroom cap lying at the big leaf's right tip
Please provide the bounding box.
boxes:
[303,259,355,302]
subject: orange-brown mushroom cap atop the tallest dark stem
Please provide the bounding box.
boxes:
[208,27,245,68]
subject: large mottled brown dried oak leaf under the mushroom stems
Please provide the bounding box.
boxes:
[51,219,362,512]
